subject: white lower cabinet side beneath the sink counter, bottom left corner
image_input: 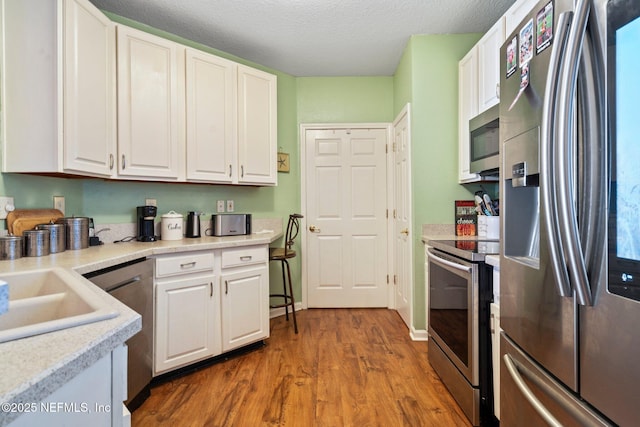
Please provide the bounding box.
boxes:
[9,344,131,427]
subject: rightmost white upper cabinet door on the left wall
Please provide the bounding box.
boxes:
[238,65,278,185]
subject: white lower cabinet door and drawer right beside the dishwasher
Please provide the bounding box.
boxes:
[153,252,220,375]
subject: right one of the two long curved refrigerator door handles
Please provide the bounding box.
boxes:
[555,0,593,305]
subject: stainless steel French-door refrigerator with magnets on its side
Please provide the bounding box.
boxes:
[500,0,640,427]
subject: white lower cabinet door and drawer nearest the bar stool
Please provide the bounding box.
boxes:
[220,246,269,352]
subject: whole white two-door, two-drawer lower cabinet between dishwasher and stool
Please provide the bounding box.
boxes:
[153,245,269,376]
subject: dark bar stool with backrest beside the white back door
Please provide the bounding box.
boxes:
[269,214,304,334]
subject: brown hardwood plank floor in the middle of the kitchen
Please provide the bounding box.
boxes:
[132,309,470,427]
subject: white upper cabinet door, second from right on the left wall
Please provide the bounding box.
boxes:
[186,48,238,184]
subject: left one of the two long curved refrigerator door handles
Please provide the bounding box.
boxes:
[540,12,573,297]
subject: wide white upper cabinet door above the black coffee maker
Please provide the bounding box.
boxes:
[117,25,184,180]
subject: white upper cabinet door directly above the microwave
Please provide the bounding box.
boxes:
[477,18,504,113]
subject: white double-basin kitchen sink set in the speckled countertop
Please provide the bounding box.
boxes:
[0,268,118,342]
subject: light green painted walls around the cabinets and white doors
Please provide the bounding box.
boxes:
[0,14,479,329]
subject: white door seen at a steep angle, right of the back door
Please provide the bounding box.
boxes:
[393,104,413,327]
